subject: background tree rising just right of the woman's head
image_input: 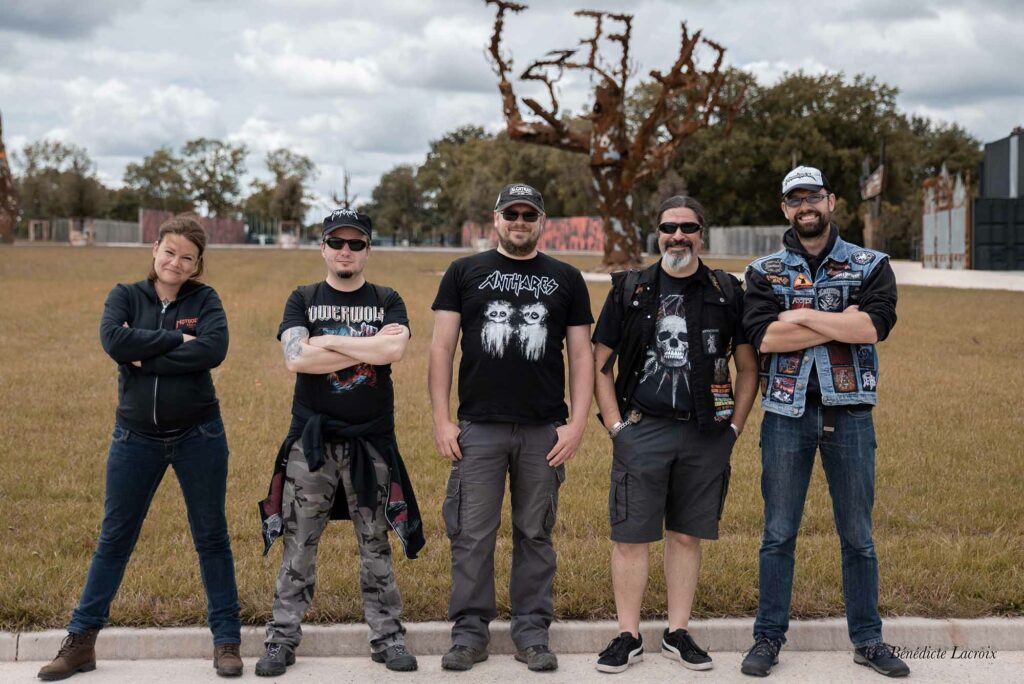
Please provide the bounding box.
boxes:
[181,138,248,216]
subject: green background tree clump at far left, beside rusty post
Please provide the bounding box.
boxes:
[13,140,106,219]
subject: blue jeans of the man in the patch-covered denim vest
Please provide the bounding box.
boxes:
[754,405,882,647]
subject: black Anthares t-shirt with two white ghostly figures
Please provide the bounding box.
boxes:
[432,250,594,423]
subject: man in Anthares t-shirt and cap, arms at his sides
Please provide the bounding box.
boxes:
[428,183,594,671]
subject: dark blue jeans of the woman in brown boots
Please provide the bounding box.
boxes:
[68,418,241,644]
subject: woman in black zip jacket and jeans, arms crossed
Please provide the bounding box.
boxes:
[39,216,242,680]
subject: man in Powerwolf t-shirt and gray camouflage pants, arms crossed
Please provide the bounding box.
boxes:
[256,209,424,677]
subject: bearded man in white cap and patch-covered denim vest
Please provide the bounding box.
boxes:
[741,166,909,677]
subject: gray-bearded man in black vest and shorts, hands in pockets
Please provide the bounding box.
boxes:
[594,196,757,673]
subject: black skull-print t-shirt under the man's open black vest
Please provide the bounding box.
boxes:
[633,270,698,418]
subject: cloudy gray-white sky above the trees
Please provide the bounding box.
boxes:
[0,0,1024,214]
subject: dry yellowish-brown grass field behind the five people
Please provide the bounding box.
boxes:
[0,248,1024,630]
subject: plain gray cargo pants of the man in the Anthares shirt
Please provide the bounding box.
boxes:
[441,421,565,649]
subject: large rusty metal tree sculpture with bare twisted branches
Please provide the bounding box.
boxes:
[485,0,743,270]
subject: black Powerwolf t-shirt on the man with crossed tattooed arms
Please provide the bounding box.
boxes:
[278,281,409,423]
